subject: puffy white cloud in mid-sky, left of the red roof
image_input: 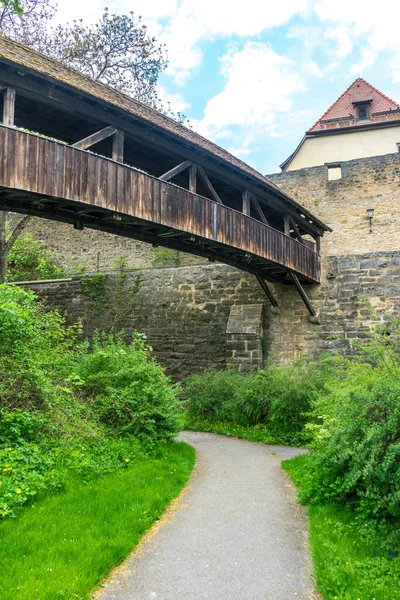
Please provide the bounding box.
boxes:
[196,42,304,147]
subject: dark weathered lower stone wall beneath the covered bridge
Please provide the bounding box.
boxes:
[18,251,400,377]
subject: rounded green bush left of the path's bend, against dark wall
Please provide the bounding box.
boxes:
[76,334,181,442]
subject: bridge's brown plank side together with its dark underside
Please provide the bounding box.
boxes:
[0,126,320,283]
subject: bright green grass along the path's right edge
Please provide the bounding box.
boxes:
[282,456,400,600]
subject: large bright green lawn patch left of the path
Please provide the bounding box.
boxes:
[0,442,195,600]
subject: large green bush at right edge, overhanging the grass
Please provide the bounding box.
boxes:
[302,377,400,536]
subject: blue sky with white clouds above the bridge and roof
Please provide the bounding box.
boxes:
[56,0,400,174]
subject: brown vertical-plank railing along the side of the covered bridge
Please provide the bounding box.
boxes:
[0,126,320,282]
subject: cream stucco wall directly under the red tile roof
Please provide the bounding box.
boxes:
[286,125,400,171]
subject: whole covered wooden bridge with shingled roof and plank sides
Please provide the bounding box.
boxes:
[0,38,329,313]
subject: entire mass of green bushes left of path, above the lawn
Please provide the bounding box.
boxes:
[0,285,184,518]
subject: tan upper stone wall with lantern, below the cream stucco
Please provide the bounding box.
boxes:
[268,153,400,256]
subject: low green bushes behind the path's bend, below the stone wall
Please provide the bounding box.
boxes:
[184,363,324,444]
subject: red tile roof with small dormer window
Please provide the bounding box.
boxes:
[307,77,400,133]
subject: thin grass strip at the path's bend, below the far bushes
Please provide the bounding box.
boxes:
[185,417,296,444]
